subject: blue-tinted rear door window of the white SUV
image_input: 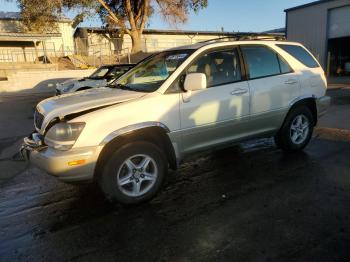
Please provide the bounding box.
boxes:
[242,46,280,79]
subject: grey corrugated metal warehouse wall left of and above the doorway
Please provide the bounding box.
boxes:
[286,0,350,68]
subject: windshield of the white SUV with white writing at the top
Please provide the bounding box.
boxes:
[114,50,192,92]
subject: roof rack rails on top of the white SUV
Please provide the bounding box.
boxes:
[200,33,286,43]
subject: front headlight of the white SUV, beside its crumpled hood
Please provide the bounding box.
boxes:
[45,122,85,150]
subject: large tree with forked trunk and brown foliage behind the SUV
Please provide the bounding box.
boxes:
[17,0,208,53]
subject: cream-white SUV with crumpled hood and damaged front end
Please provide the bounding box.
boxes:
[22,40,330,204]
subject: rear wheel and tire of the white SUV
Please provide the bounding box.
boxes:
[274,106,315,152]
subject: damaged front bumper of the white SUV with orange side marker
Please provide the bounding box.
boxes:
[20,133,102,183]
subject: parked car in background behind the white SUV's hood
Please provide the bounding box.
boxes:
[56,64,135,95]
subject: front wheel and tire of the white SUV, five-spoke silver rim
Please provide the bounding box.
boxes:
[98,142,167,205]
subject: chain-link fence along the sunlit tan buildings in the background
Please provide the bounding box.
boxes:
[0,36,205,67]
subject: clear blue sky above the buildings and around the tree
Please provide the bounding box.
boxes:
[0,0,314,32]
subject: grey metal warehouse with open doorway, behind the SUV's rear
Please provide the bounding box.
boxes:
[285,0,350,77]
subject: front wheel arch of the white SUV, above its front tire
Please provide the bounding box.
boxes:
[94,122,177,180]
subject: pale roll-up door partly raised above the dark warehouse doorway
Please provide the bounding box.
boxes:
[328,5,350,38]
